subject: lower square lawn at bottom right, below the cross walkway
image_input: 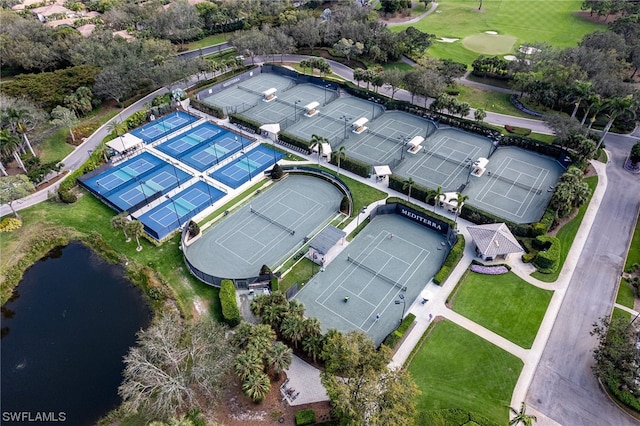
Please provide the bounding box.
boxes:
[408,321,523,424]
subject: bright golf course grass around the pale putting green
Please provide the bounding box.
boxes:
[392,0,606,65]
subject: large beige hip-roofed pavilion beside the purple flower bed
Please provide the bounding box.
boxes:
[467,223,524,261]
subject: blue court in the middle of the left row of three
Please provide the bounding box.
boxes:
[107,163,192,212]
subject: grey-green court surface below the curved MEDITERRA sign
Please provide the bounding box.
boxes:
[295,214,448,344]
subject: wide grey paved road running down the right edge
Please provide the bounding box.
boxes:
[526,134,640,426]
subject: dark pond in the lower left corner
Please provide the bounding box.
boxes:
[0,243,151,425]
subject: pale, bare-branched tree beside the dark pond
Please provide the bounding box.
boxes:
[118,313,235,419]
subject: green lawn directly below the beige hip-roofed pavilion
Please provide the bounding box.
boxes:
[453,271,553,349]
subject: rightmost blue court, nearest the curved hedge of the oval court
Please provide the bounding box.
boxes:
[209,145,284,189]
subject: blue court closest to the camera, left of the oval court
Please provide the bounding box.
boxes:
[137,181,226,240]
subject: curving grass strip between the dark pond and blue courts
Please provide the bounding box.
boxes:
[0,192,221,319]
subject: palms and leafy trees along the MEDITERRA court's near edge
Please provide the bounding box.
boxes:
[248,292,418,425]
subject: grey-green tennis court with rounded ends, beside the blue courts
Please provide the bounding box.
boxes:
[184,175,342,279]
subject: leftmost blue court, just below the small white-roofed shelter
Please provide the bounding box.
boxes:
[84,152,165,196]
